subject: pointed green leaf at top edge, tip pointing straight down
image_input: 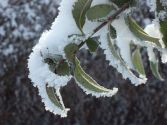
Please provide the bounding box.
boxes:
[72,0,93,34]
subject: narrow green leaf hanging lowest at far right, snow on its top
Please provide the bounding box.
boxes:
[150,61,164,81]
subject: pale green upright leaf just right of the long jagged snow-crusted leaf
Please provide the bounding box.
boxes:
[131,45,146,76]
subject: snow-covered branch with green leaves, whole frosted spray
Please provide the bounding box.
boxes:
[28,0,167,117]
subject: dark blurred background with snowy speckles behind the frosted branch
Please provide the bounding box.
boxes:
[0,0,167,125]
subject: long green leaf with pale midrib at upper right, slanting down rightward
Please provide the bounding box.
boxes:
[125,16,161,47]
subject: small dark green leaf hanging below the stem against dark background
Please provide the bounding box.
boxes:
[86,38,98,52]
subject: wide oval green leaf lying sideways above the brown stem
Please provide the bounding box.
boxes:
[86,4,114,21]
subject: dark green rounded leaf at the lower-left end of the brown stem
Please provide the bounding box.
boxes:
[64,43,78,63]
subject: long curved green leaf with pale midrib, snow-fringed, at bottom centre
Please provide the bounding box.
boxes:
[74,57,116,94]
